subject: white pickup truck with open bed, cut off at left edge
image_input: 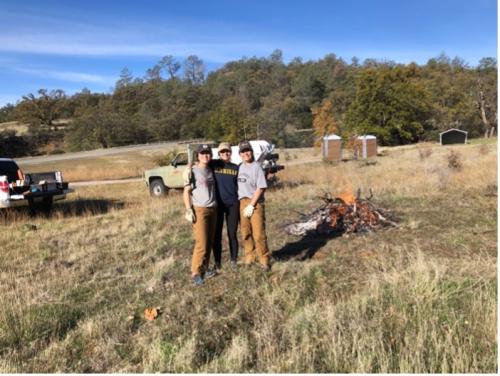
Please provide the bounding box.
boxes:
[0,158,74,212]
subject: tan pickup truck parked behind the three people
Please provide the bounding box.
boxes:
[143,140,285,197]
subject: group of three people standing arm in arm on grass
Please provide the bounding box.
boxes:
[183,141,270,285]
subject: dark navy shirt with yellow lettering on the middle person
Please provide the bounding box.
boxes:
[210,159,238,205]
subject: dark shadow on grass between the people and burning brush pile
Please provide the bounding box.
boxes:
[272,232,341,261]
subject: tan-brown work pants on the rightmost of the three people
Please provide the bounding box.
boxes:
[240,198,270,265]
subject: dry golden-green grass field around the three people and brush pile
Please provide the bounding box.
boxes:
[0,140,498,373]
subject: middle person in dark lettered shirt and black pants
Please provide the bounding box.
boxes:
[210,142,240,270]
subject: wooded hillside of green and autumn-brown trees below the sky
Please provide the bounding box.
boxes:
[0,50,497,155]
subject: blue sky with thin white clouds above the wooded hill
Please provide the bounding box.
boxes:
[0,0,497,106]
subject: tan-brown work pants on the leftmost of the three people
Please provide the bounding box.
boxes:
[191,206,217,275]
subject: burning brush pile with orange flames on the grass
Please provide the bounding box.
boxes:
[285,190,398,236]
